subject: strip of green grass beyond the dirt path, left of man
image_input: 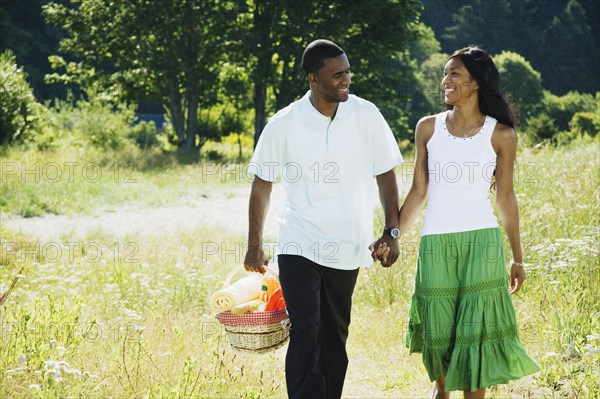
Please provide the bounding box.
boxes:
[0,148,252,217]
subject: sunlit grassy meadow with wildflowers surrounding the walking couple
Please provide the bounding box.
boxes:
[0,142,600,398]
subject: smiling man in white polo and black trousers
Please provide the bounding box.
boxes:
[244,40,402,399]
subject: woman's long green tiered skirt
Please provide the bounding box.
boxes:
[406,228,540,391]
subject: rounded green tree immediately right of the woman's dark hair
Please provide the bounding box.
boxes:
[494,51,544,120]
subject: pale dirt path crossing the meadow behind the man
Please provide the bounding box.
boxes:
[0,184,284,241]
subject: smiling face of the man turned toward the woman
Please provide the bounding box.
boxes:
[309,54,352,103]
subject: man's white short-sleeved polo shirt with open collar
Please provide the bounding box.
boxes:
[249,91,402,270]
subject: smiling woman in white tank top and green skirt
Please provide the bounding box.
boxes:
[377,47,539,398]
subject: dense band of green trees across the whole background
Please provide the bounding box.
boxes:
[0,0,600,155]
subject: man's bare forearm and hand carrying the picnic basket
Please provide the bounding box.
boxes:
[244,176,273,273]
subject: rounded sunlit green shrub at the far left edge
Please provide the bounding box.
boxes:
[0,50,43,144]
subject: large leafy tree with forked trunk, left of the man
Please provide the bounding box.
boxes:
[44,0,238,160]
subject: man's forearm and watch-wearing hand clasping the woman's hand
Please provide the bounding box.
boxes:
[372,169,400,267]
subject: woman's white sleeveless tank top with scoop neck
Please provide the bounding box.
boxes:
[421,111,498,235]
